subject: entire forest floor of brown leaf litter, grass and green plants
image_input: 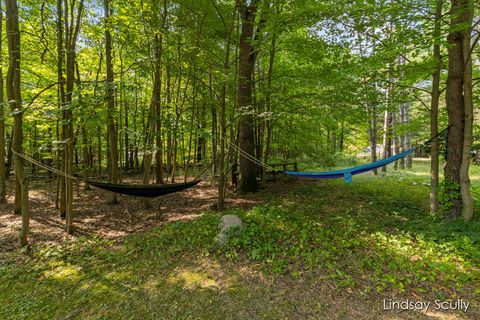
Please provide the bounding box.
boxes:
[0,161,480,319]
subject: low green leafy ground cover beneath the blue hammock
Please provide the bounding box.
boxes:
[226,179,480,299]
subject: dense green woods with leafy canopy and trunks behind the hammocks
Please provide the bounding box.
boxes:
[0,0,480,243]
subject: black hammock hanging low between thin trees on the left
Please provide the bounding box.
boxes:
[88,179,201,198]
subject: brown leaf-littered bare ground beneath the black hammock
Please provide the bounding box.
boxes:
[0,180,256,252]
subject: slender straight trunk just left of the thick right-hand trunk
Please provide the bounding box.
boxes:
[430,0,443,213]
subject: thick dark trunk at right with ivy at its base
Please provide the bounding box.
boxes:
[444,0,467,218]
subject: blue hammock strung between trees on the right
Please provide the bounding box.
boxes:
[284,148,415,183]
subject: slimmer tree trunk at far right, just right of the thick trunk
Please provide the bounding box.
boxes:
[460,0,474,221]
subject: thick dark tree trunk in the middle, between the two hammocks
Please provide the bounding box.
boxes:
[237,0,258,193]
